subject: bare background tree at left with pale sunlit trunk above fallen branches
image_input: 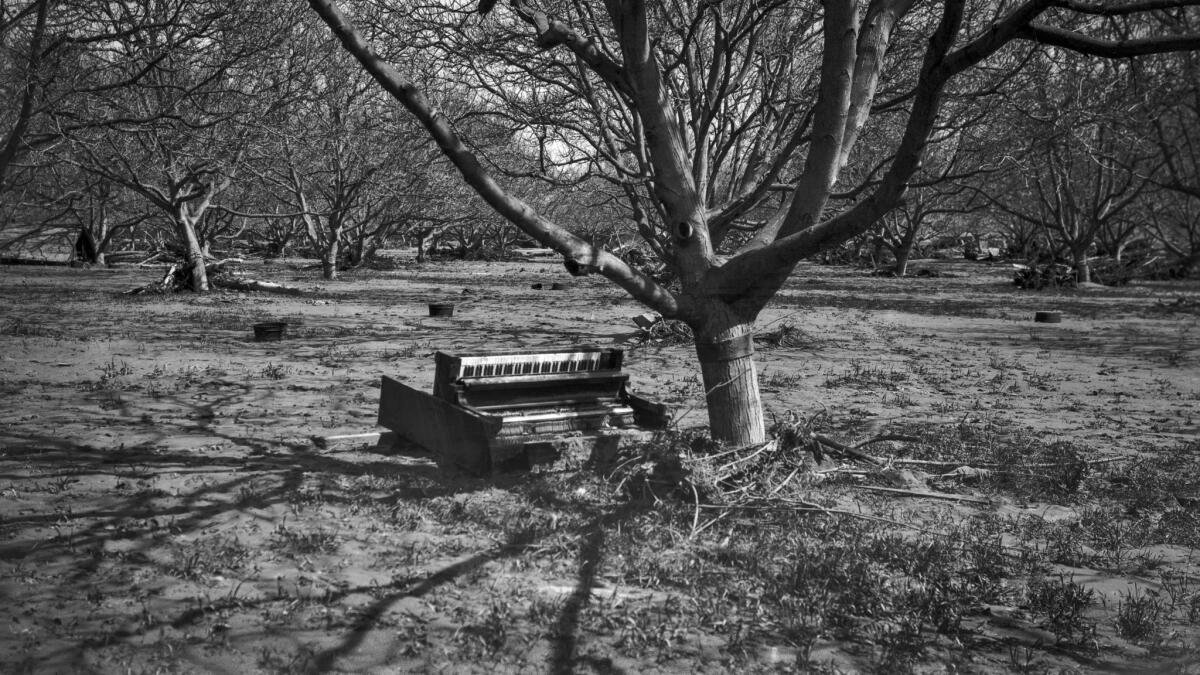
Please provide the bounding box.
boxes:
[53,0,300,291]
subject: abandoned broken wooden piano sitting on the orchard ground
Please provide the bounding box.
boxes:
[379,347,670,476]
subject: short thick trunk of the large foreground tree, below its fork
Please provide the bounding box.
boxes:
[694,312,767,446]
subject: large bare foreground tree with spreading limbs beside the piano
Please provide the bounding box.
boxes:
[310,0,1200,443]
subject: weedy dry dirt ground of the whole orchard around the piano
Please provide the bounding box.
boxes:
[0,254,1200,673]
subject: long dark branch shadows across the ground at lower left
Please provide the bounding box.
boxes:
[0,417,647,673]
